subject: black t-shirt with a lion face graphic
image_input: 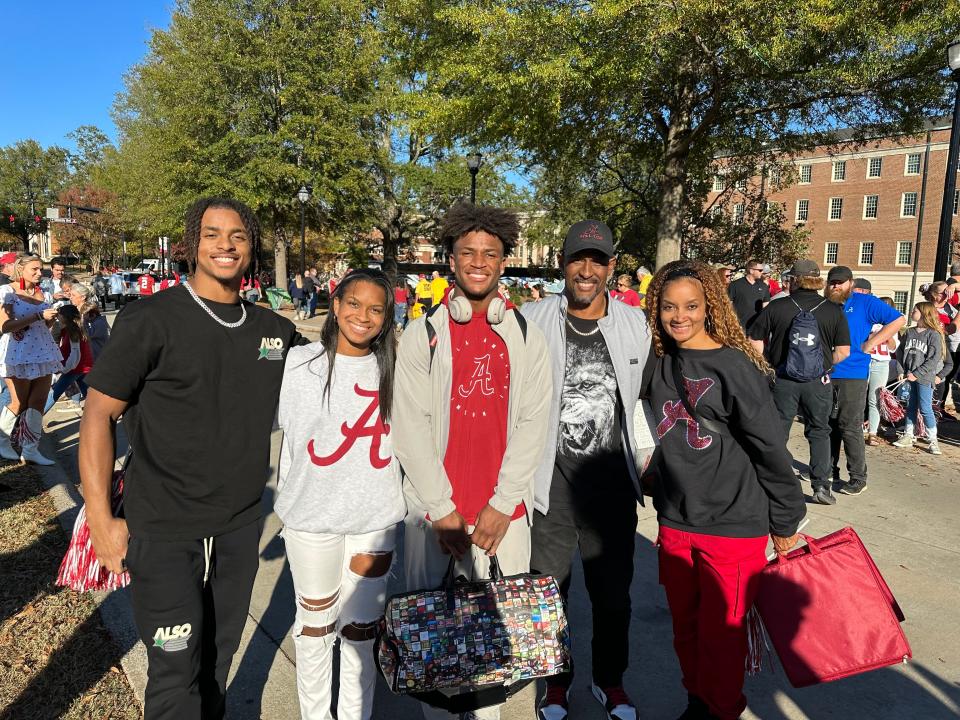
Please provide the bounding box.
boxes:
[550,315,633,507]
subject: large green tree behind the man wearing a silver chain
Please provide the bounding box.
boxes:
[110,0,380,284]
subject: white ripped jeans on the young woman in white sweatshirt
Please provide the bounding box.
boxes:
[282,526,397,720]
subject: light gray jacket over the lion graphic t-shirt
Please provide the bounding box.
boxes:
[521,293,650,514]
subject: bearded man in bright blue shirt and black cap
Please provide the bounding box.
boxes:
[826,265,907,495]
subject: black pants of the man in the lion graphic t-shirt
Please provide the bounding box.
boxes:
[530,469,637,688]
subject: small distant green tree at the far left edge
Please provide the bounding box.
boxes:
[0,140,70,252]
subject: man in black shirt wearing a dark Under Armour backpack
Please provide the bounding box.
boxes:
[749,260,850,505]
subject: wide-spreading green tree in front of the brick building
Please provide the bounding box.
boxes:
[418,0,960,265]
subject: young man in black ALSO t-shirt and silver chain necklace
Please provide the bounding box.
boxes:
[79,198,299,720]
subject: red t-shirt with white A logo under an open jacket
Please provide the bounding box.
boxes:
[443,313,526,525]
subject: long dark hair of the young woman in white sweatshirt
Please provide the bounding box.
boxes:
[308,268,397,422]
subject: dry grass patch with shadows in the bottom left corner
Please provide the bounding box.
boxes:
[0,461,141,720]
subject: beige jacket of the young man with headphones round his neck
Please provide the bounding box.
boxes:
[391,305,556,523]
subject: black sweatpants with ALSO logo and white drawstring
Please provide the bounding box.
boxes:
[127,522,260,720]
